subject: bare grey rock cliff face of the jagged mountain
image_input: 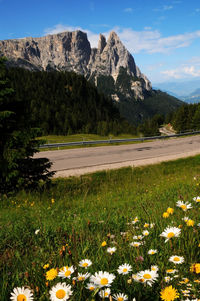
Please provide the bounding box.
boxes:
[0,30,152,101]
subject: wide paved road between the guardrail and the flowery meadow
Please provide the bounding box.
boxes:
[34,136,200,177]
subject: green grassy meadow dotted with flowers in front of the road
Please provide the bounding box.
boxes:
[0,156,200,301]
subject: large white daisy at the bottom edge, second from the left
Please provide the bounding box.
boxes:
[49,282,73,301]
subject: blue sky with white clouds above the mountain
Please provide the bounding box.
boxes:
[0,0,200,84]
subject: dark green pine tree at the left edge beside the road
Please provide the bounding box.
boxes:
[0,58,53,193]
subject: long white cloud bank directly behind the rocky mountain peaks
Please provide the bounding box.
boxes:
[44,24,200,54]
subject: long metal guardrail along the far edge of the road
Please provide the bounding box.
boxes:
[39,131,200,149]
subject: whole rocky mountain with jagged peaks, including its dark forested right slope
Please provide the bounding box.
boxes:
[0,30,182,124]
